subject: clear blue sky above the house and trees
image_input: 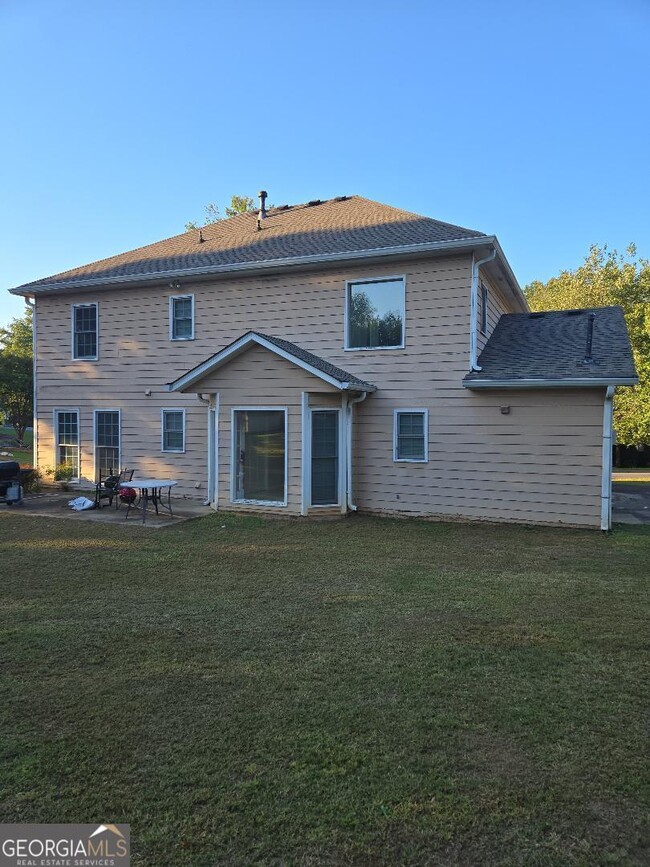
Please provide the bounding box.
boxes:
[0,0,650,324]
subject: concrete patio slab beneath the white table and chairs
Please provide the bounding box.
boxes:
[5,490,213,530]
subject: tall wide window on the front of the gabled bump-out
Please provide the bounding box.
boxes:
[232,409,287,505]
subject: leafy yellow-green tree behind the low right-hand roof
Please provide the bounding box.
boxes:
[524,244,650,445]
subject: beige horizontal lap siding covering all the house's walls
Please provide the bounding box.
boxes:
[37,256,604,526]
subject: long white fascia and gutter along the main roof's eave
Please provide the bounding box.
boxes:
[9,235,498,298]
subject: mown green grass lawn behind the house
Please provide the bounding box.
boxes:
[0,510,650,867]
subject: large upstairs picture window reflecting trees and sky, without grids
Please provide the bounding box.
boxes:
[345,277,404,349]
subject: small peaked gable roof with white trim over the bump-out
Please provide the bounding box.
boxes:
[167,331,377,391]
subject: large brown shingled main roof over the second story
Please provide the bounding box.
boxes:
[11,196,491,295]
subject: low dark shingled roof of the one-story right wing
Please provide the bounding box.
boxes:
[463,307,638,388]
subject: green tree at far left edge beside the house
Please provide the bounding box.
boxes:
[0,310,34,444]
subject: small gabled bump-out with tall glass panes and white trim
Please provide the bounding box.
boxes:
[169,331,375,516]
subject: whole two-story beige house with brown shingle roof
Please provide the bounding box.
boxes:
[11,194,637,529]
